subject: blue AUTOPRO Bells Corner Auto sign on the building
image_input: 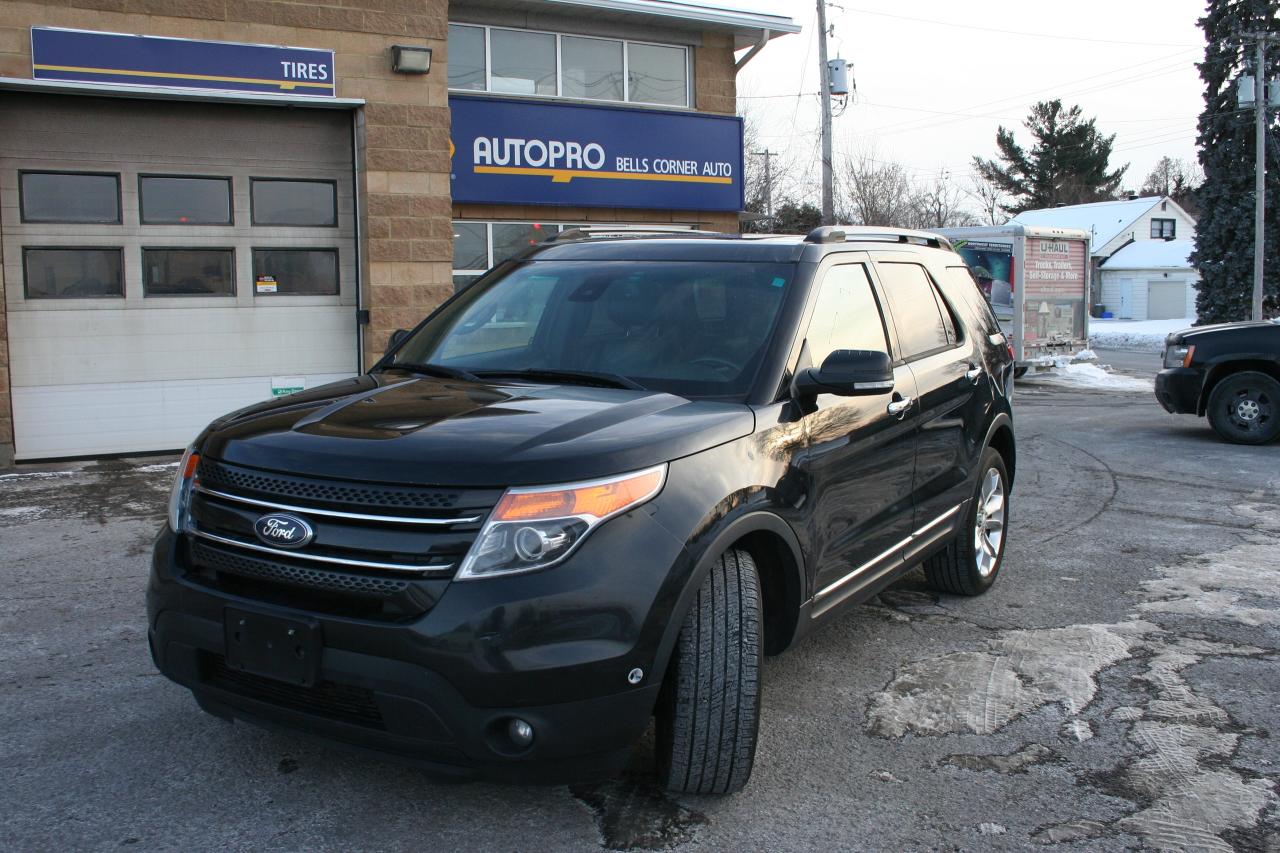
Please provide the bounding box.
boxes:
[449,97,742,213]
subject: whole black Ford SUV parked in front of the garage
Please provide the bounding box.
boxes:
[147,228,1015,793]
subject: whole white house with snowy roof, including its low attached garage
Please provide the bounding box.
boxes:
[1012,196,1199,320]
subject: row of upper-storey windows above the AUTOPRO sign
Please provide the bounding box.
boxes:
[449,24,690,106]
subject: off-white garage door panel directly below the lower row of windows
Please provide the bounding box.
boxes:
[9,305,356,388]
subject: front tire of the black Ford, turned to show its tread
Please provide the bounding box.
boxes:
[655,551,760,794]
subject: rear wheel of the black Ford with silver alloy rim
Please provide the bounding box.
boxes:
[924,447,1009,596]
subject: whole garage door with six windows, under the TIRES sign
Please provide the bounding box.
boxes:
[0,93,357,459]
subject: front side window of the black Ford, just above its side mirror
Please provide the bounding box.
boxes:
[805,264,888,366]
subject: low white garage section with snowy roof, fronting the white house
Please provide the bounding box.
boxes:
[1101,240,1199,320]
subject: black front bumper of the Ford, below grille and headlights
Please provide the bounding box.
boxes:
[147,512,685,781]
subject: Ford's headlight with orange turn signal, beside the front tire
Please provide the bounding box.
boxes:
[457,465,667,580]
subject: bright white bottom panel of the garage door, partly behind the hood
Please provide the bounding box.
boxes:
[13,373,351,459]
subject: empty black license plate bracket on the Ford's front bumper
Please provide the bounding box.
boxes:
[223,607,321,686]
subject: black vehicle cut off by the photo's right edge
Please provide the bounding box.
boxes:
[1156,320,1280,444]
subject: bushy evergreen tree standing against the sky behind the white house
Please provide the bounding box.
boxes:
[973,99,1129,214]
